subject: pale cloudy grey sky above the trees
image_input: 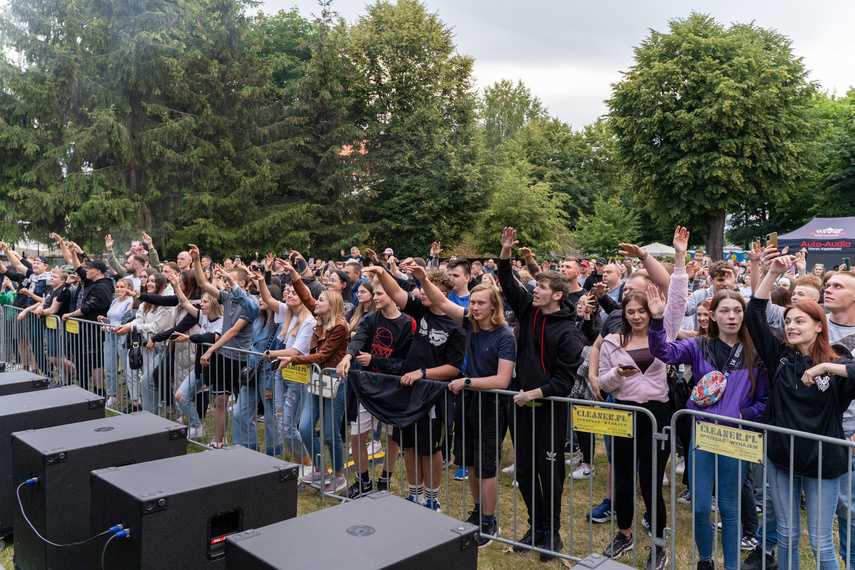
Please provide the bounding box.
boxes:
[260,0,855,129]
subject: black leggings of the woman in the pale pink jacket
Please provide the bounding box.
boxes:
[612,400,671,538]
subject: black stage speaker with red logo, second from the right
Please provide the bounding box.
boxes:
[89,446,297,570]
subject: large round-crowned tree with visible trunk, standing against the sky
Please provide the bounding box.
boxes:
[608,14,815,257]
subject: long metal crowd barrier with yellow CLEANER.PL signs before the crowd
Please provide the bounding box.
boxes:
[0,298,855,568]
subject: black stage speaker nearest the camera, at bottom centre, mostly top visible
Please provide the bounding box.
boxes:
[226,493,479,570]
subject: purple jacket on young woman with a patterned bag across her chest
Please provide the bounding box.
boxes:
[647,319,772,421]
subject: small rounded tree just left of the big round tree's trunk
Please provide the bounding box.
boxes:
[570,196,639,255]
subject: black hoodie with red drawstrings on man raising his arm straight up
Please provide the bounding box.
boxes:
[499,259,585,398]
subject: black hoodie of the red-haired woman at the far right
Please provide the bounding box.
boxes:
[745,298,855,479]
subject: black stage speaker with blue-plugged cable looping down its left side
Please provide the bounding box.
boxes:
[12,412,187,570]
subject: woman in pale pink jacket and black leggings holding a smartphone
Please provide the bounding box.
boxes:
[599,227,689,570]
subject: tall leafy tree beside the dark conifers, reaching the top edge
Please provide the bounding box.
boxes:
[349,0,484,252]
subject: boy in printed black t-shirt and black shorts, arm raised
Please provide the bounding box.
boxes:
[366,267,466,511]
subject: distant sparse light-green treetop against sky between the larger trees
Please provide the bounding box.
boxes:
[481,79,548,149]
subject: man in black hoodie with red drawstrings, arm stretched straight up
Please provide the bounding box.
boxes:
[499,228,584,562]
